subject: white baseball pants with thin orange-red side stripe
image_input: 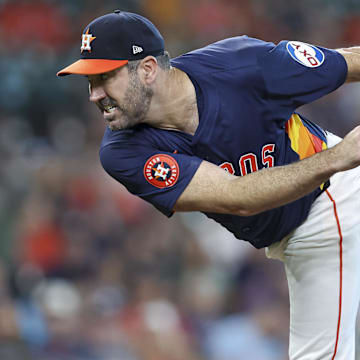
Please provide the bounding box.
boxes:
[266,133,360,360]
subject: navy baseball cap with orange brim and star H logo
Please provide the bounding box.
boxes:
[56,10,164,76]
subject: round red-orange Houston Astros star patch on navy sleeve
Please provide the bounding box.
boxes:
[144,154,179,188]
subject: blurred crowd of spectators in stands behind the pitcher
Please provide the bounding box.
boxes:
[0,0,360,360]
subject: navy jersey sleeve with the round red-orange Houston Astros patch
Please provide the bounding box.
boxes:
[99,143,202,217]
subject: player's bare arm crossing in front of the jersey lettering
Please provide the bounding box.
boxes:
[174,126,360,216]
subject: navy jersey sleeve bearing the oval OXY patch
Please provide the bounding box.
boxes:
[258,41,347,109]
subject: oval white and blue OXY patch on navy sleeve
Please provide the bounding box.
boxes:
[286,41,325,68]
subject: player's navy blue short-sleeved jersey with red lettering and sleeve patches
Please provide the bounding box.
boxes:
[100,36,347,248]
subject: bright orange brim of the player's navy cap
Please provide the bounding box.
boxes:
[56,59,128,76]
